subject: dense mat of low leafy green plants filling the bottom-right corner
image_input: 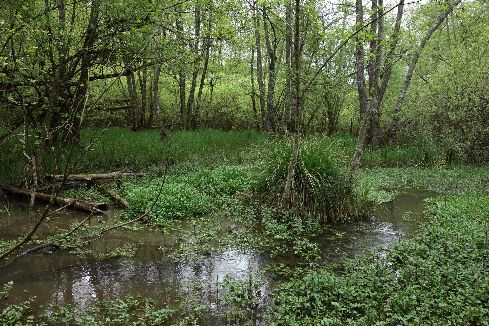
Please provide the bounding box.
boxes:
[270,195,489,325]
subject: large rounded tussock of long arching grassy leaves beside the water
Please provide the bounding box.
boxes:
[257,142,355,223]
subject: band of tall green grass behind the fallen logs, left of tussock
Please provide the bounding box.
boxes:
[0,127,267,185]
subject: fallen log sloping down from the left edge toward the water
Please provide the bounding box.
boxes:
[1,187,108,214]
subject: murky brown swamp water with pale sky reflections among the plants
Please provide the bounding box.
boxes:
[0,190,435,318]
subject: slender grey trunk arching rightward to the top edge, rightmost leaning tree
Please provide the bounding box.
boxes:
[388,0,461,143]
